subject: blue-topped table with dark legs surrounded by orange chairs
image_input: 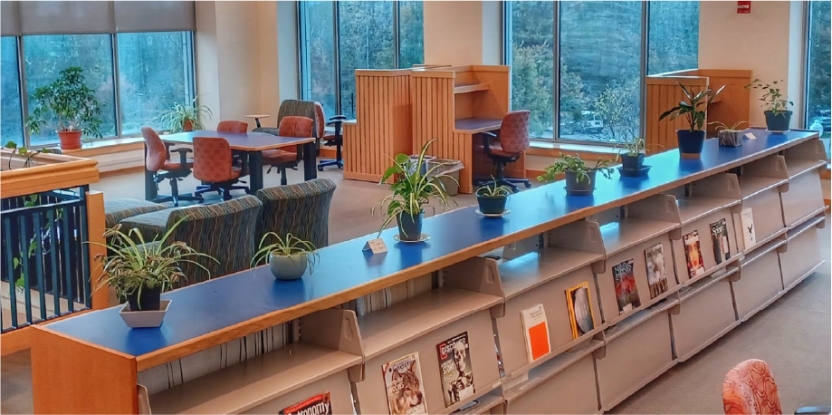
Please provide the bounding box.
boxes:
[144,130,318,200]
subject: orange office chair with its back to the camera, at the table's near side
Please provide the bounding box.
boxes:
[194,137,248,200]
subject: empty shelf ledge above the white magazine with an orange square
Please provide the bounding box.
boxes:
[499,247,604,301]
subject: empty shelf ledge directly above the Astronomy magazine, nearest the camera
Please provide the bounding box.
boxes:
[150,342,362,414]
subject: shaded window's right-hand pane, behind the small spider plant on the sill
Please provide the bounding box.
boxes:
[116,32,193,135]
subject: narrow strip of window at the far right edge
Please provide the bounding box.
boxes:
[805,1,830,140]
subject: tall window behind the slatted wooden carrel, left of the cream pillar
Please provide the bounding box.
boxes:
[299,1,424,118]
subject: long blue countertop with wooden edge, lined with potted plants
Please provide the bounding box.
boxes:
[47,130,814,357]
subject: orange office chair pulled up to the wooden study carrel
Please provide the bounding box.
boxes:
[479,110,532,193]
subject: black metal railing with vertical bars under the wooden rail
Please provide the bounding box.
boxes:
[0,186,94,332]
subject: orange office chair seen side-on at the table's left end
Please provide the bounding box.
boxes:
[142,127,202,206]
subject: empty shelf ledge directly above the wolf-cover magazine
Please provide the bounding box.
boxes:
[358,287,503,360]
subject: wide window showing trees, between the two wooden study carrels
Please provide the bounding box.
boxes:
[506,1,699,143]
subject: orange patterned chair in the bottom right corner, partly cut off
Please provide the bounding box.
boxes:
[722,359,832,415]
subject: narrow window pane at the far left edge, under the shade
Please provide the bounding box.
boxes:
[0,36,23,145]
